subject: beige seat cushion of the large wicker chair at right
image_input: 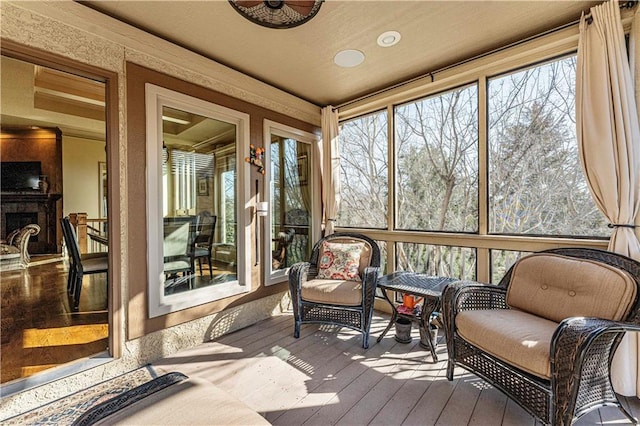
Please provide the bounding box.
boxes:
[456,309,558,379]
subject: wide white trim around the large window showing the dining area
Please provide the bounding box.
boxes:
[145,83,251,318]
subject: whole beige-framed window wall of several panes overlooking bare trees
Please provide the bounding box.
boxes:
[337,53,610,282]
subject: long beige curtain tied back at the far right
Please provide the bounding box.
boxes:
[576,0,640,396]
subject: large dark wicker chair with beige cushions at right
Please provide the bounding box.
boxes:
[442,248,640,425]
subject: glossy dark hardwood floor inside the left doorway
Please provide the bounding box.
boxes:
[0,255,109,384]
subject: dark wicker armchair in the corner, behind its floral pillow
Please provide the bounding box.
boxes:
[289,233,380,349]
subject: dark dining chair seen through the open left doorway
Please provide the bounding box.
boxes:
[60,216,109,311]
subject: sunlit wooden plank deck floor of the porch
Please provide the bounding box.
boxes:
[154,315,640,426]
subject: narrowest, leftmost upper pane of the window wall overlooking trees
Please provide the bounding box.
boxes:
[337,111,389,228]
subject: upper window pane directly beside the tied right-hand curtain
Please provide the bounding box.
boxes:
[488,56,608,236]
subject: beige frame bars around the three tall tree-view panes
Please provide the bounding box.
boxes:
[336,25,608,282]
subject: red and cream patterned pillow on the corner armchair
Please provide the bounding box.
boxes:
[317,241,364,281]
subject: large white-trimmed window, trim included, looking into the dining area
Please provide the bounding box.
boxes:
[145,84,249,318]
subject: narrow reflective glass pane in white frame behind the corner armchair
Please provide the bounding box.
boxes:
[270,135,312,271]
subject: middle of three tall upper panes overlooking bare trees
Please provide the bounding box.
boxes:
[395,85,478,232]
